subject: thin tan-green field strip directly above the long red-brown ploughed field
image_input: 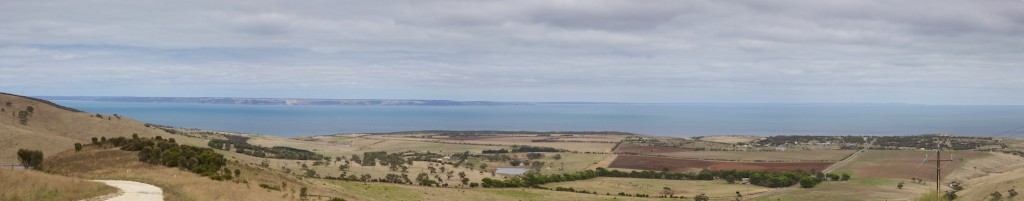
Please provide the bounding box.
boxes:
[655,150,856,162]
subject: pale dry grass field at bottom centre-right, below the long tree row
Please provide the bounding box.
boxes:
[544,177,769,197]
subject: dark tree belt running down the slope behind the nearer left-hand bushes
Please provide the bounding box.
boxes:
[207,135,326,160]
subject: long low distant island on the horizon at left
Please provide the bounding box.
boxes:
[36,96,534,106]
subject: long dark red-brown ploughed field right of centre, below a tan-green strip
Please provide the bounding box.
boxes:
[608,155,831,171]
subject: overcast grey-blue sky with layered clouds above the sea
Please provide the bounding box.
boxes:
[0,0,1024,105]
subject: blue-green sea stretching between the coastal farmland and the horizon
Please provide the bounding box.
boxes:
[55,101,1024,136]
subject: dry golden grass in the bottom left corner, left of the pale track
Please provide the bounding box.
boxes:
[0,169,118,201]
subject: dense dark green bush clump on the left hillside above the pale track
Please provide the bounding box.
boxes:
[100,136,232,180]
